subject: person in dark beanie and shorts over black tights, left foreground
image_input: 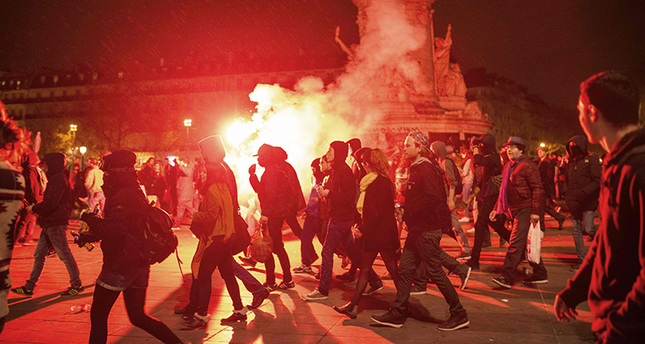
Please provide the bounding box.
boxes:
[73,150,182,343]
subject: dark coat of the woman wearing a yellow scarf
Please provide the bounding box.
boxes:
[360,176,400,252]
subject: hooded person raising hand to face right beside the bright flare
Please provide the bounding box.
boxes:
[249,144,305,291]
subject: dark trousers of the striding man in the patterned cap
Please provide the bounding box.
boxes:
[392,230,466,317]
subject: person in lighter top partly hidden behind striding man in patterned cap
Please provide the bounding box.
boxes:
[424,141,471,260]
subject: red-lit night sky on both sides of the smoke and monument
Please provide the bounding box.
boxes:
[0,0,645,108]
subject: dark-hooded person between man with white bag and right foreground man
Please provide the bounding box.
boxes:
[564,135,602,270]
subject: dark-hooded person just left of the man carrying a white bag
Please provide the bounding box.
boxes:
[466,134,511,269]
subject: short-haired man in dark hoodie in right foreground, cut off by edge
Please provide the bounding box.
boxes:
[553,71,645,343]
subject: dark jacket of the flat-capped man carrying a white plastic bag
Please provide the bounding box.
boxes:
[503,155,545,216]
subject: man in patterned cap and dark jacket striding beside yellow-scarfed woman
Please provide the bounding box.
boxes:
[371,132,471,331]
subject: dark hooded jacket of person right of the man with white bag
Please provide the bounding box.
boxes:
[564,135,602,217]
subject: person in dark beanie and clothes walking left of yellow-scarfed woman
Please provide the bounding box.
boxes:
[301,141,383,301]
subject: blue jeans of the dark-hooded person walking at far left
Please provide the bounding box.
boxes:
[25,225,81,290]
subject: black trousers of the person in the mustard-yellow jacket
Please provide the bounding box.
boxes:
[189,237,244,315]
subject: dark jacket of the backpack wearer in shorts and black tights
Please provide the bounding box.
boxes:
[83,172,148,272]
